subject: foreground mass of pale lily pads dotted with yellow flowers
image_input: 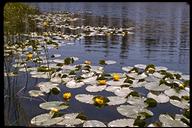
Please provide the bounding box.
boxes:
[4,45,190,127]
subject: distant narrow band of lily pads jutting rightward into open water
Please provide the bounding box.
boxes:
[21,12,134,40]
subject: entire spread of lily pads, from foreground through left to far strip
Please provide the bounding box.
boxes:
[4,10,190,127]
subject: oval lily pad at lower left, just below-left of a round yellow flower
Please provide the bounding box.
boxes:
[39,101,69,110]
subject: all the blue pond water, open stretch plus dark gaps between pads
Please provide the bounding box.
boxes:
[4,2,189,126]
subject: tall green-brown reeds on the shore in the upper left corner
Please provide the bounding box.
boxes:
[3,3,40,42]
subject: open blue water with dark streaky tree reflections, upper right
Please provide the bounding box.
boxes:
[29,3,189,73]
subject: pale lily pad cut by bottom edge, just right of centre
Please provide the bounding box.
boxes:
[108,119,135,127]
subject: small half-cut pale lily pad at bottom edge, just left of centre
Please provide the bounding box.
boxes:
[83,120,107,127]
